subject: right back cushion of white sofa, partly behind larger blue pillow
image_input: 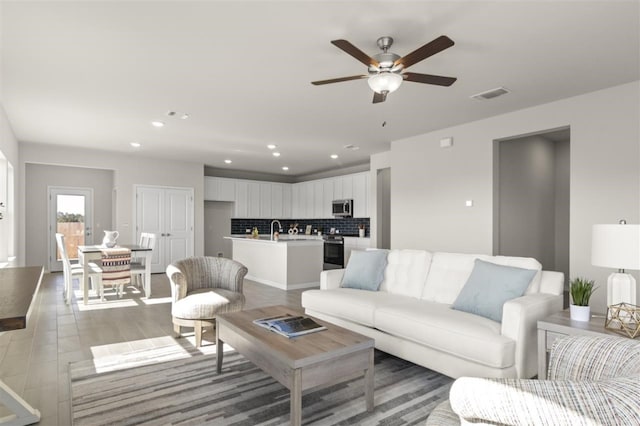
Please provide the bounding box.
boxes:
[421,252,542,305]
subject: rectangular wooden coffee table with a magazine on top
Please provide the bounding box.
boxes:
[216,306,374,425]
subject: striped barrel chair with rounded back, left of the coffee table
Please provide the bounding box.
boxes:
[166,257,247,347]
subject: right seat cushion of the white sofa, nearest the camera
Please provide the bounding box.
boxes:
[376,300,516,368]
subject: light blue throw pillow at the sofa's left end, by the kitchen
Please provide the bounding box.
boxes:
[341,250,387,291]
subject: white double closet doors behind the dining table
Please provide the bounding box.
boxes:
[136,186,193,273]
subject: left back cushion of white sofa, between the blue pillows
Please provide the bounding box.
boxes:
[380,250,431,298]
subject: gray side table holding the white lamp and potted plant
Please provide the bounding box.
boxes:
[538,309,624,380]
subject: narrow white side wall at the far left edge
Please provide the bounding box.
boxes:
[0,103,19,265]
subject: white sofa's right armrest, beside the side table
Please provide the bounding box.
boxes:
[502,293,562,378]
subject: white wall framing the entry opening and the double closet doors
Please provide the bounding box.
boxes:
[19,143,204,258]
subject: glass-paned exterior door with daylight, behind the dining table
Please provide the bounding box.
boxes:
[48,186,94,272]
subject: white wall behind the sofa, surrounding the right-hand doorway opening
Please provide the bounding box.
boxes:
[391,81,640,312]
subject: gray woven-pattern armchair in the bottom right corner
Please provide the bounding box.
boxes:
[427,336,640,426]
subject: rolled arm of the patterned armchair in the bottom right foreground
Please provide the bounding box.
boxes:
[449,377,617,425]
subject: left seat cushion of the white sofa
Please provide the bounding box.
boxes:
[301,288,406,327]
